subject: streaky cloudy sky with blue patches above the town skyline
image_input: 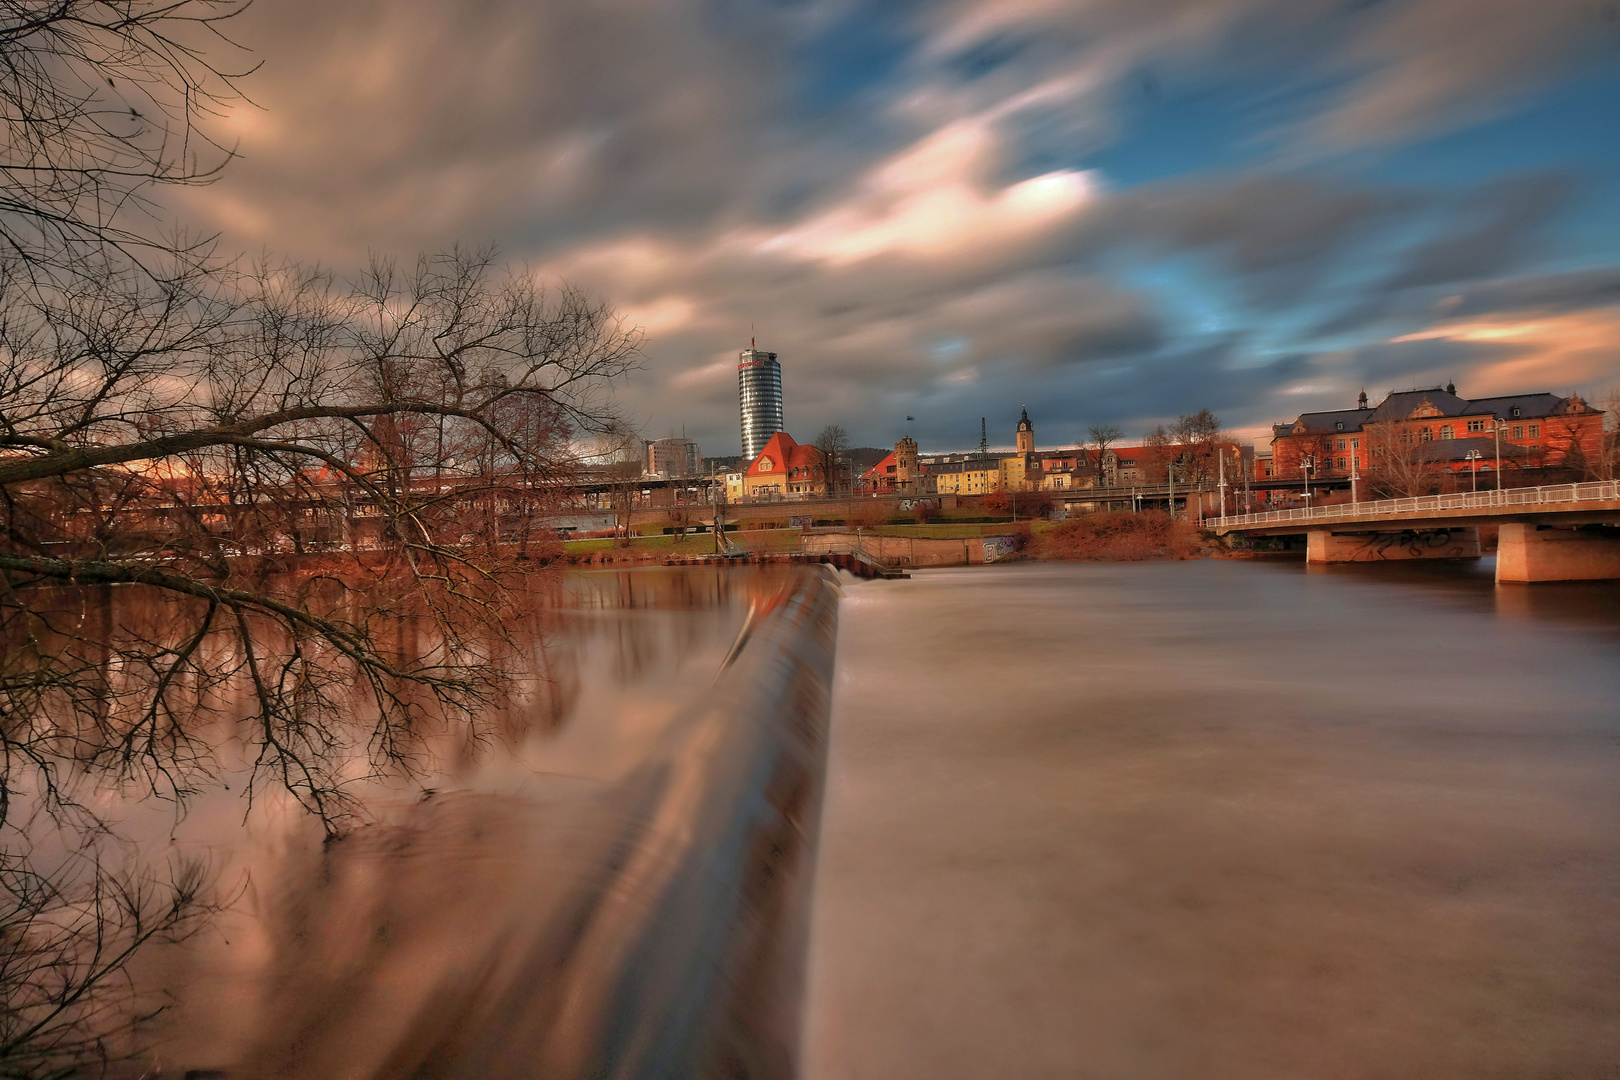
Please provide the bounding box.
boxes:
[168,0,1620,455]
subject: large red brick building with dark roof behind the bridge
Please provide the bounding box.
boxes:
[1270,384,1604,494]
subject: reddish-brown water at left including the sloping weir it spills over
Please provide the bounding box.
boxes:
[131,567,839,1080]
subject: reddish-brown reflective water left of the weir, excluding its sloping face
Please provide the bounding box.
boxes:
[23,568,810,1077]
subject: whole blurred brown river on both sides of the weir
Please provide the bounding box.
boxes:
[22,560,1620,1080]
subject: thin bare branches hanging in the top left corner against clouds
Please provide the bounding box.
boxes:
[0,0,251,283]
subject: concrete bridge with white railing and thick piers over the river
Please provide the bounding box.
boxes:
[1205,479,1620,585]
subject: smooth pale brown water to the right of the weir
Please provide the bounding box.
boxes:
[805,560,1620,1080]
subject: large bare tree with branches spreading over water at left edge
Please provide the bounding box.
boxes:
[0,0,637,1077]
